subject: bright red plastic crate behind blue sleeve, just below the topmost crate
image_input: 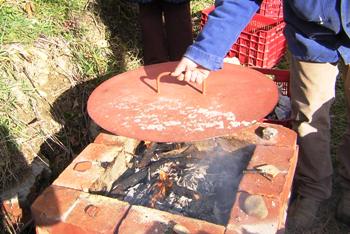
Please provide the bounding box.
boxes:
[201,7,286,68]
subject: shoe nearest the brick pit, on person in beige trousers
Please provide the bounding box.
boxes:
[287,195,321,231]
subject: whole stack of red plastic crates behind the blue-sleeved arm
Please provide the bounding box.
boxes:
[201,0,291,128]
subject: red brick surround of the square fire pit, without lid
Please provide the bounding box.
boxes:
[32,123,297,234]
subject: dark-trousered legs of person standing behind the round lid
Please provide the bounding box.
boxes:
[130,0,193,65]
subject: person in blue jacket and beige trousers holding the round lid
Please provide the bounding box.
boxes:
[172,0,350,229]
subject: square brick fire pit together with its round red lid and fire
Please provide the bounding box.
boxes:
[31,62,297,234]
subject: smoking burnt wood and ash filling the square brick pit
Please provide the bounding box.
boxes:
[105,138,255,225]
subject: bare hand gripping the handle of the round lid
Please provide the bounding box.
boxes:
[171,57,210,84]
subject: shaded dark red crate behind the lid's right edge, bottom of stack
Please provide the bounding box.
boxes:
[253,67,292,128]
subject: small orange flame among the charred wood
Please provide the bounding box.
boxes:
[150,170,173,207]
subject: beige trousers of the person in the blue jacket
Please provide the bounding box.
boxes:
[291,58,350,201]
